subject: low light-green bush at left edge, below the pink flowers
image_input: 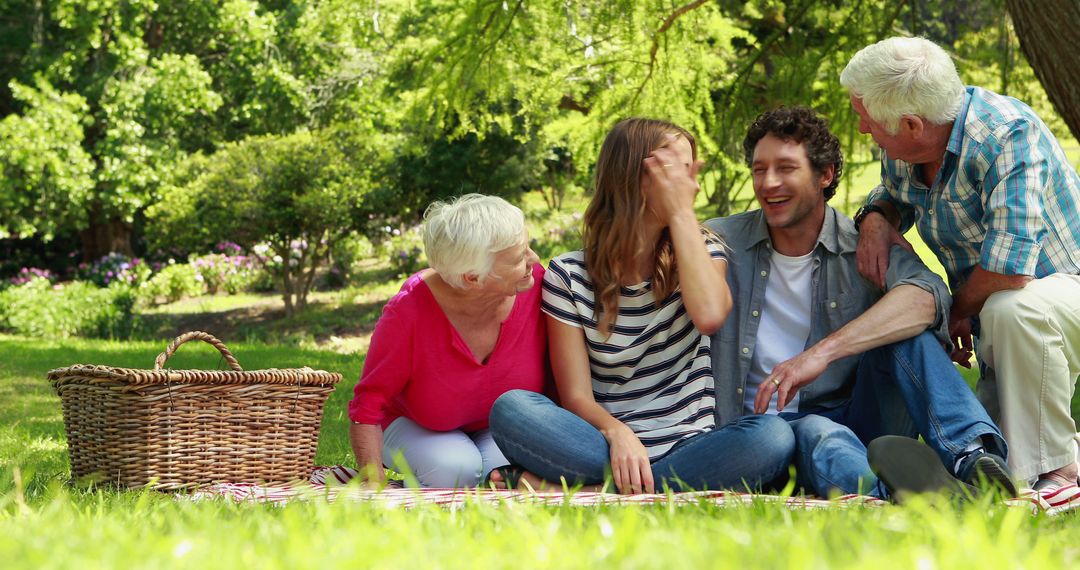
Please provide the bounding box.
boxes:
[0,277,136,339]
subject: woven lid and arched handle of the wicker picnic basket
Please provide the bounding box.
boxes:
[49,330,341,389]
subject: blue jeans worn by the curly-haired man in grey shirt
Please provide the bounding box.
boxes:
[780,333,1008,498]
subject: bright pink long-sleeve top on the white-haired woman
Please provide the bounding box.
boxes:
[349,263,549,432]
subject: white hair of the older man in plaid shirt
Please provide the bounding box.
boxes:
[840,38,963,135]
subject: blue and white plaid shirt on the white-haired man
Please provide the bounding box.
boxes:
[866,87,1080,288]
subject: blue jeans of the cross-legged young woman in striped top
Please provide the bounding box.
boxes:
[490,390,795,491]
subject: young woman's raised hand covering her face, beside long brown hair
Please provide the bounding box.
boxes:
[640,138,702,225]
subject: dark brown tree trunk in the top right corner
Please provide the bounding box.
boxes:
[1005,0,1080,139]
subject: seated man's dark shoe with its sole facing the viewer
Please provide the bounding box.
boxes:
[866,435,978,503]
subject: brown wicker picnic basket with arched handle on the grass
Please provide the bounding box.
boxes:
[49,331,341,490]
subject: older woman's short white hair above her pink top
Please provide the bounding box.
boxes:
[423,194,525,288]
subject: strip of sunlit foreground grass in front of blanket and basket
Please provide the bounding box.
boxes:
[0,486,1080,569]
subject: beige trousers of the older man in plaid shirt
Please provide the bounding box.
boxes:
[977,274,1080,483]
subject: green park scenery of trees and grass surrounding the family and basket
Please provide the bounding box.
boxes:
[0,0,1080,568]
